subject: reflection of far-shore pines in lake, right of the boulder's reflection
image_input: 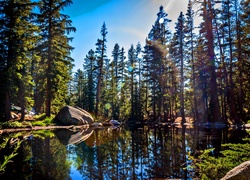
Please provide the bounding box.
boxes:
[61,126,248,179]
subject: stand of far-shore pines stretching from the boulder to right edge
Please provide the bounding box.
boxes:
[68,0,250,123]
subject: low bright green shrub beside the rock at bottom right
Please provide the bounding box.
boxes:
[189,138,250,180]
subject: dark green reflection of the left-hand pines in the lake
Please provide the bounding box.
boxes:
[0,131,70,180]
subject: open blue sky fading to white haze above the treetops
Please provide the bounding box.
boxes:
[64,0,188,71]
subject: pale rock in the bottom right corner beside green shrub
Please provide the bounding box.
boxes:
[221,161,250,180]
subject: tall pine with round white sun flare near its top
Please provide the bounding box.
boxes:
[145,6,171,119]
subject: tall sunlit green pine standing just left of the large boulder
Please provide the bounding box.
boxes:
[36,0,76,116]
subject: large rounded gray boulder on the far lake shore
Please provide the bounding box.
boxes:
[55,106,94,125]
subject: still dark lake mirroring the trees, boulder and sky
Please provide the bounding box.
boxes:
[0,126,247,180]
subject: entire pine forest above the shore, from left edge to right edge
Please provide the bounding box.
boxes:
[0,0,250,124]
